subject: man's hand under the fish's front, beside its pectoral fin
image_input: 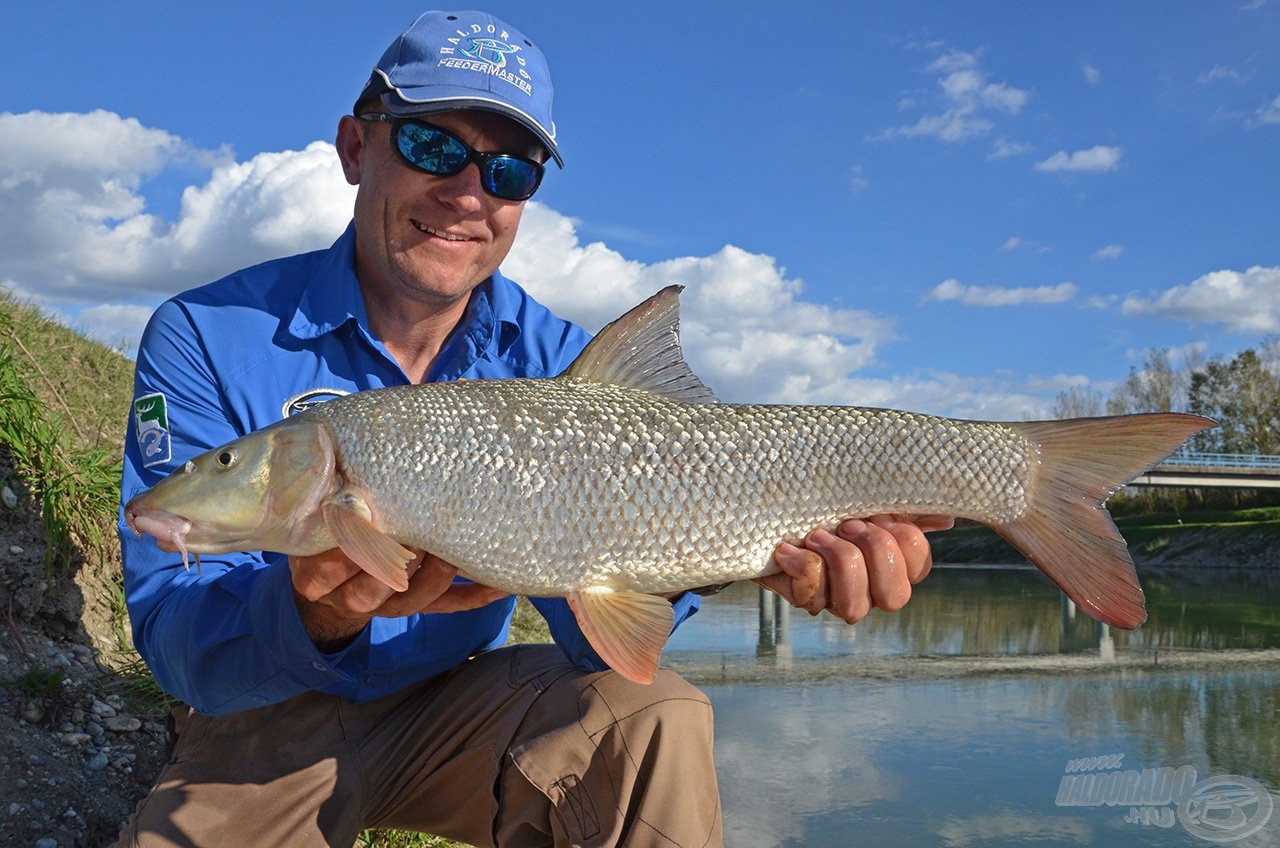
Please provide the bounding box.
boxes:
[289,548,507,651]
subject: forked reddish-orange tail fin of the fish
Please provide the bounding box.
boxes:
[995,412,1215,630]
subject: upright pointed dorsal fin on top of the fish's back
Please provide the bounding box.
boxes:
[564,286,716,404]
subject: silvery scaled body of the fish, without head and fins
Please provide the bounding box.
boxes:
[316,378,1033,596]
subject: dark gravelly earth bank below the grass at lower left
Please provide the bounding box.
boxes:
[0,471,165,848]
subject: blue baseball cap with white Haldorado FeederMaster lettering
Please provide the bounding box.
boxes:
[356,12,564,168]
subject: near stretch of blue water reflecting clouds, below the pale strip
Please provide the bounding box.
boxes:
[705,666,1280,848]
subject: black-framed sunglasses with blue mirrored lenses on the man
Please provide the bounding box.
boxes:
[356,111,545,200]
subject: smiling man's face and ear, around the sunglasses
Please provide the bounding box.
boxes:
[338,111,543,305]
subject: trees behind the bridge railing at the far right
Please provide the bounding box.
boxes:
[1053,337,1280,506]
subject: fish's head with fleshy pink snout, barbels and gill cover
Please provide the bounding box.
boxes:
[124,415,338,561]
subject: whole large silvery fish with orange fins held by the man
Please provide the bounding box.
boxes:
[124,287,1212,683]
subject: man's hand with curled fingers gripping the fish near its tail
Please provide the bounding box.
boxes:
[755,515,955,624]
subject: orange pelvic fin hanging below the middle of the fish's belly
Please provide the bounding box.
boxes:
[568,588,675,683]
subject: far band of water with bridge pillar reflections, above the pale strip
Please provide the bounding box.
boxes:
[667,566,1280,667]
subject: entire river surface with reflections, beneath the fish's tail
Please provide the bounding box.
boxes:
[664,566,1280,848]
